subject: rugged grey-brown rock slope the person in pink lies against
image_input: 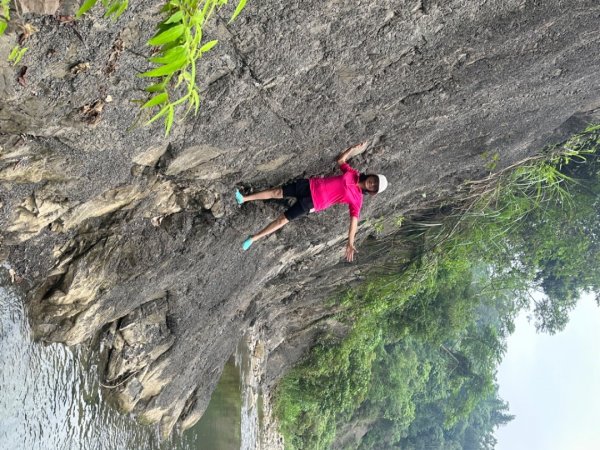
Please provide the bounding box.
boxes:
[0,0,600,433]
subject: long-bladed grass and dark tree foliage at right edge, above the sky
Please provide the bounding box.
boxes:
[454,130,600,333]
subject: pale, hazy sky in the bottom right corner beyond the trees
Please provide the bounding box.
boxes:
[495,296,600,450]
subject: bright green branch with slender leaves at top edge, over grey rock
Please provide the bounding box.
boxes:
[77,0,246,135]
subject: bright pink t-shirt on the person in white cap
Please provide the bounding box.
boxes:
[309,163,363,219]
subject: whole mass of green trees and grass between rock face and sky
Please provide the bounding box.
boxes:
[275,127,600,450]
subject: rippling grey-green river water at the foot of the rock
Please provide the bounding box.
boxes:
[0,286,258,450]
